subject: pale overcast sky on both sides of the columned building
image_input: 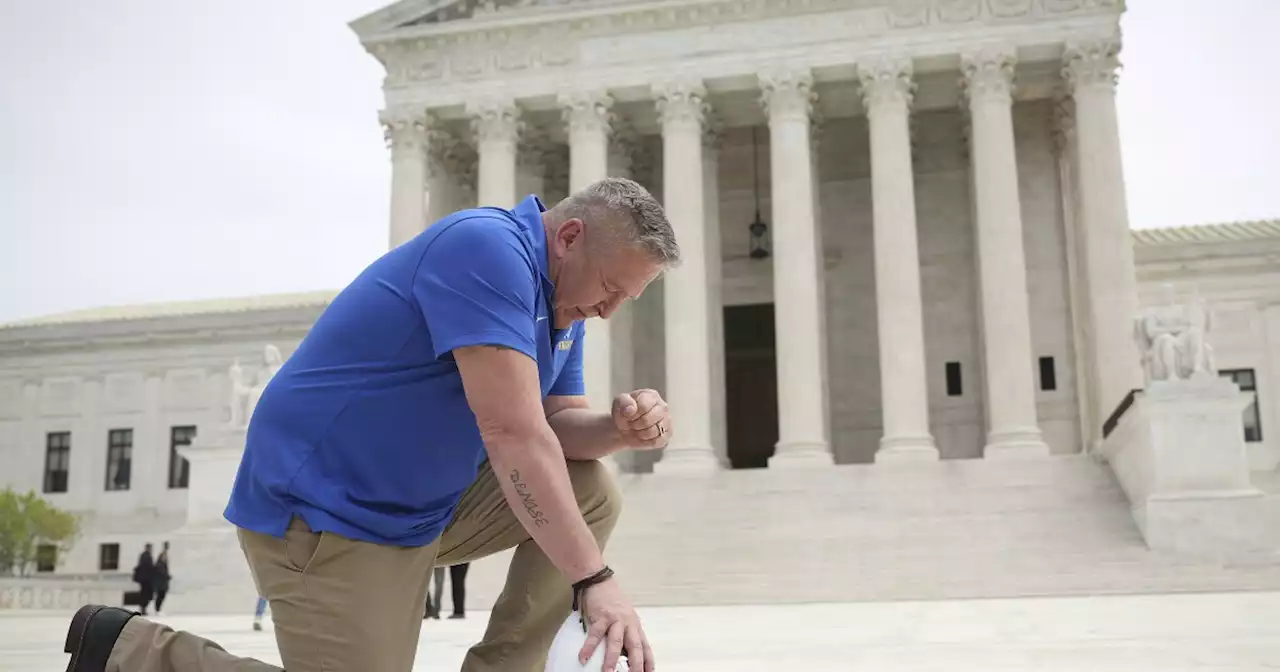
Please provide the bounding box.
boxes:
[0,0,1280,321]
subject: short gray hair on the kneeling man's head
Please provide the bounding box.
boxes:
[552,178,680,268]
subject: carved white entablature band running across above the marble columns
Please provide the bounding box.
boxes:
[362,0,1124,109]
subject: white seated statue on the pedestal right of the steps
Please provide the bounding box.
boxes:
[1134,283,1217,384]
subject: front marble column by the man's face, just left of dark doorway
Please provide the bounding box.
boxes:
[653,81,719,472]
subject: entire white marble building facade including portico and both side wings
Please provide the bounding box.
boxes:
[0,0,1280,583]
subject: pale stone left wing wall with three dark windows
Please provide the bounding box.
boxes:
[0,322,314,573]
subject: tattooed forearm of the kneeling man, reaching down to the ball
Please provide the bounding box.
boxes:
[488,425,604,582]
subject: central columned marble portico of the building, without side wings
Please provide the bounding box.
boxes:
[352,0,1142,471]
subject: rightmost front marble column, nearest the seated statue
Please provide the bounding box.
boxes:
[1062,40,1143,432]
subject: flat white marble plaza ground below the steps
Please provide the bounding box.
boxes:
[0,593,1280,672]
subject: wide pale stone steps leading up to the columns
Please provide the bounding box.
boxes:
[467,456,1280,608]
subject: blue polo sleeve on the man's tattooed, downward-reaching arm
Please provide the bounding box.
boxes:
[413,216,538,360]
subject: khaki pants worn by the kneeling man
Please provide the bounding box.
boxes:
[106,462,621,672]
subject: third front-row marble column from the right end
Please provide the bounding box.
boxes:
[858,59,938,462]
